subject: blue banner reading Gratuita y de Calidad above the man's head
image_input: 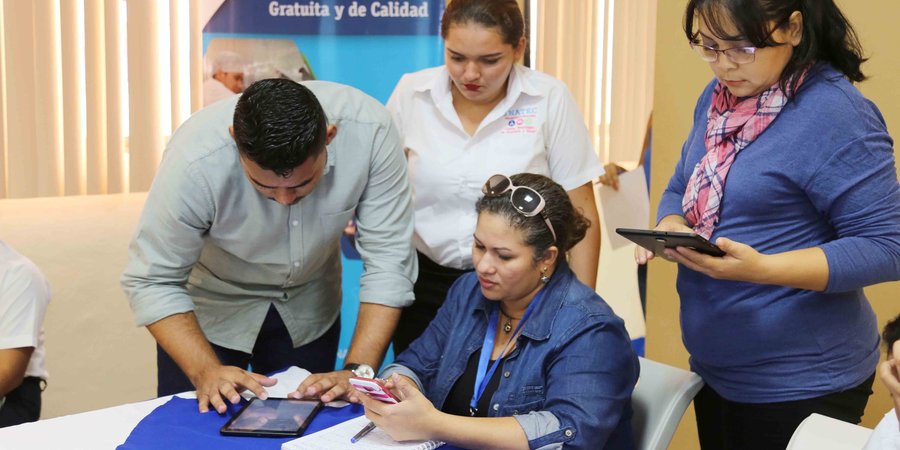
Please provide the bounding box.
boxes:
[202,0,444,103]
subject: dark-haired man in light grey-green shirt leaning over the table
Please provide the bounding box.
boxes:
[122,80,417,413]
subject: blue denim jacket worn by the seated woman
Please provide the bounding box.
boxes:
[383,263,639,449]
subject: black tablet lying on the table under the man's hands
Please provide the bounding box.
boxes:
[219,398,323,437]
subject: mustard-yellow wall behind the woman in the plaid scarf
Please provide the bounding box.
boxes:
[647,0,900,449]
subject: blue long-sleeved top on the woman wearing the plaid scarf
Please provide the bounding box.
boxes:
[657,64,900,403]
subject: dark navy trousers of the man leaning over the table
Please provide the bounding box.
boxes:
[156,306,341,397]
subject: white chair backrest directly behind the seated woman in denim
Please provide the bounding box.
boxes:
[631,358,703,450]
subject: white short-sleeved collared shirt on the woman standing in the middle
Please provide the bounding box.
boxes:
[387,64,603,269]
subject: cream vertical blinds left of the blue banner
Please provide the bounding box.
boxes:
[0,0,202,198]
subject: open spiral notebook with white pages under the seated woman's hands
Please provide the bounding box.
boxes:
[281,416,444,450]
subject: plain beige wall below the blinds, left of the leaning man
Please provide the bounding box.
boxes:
[0,194,156,418]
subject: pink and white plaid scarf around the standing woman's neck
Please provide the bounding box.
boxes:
[681,70,808,239]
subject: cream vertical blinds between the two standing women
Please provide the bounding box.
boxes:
[530,0,656,168]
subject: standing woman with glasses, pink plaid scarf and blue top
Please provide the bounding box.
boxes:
[635,0,900,450]
